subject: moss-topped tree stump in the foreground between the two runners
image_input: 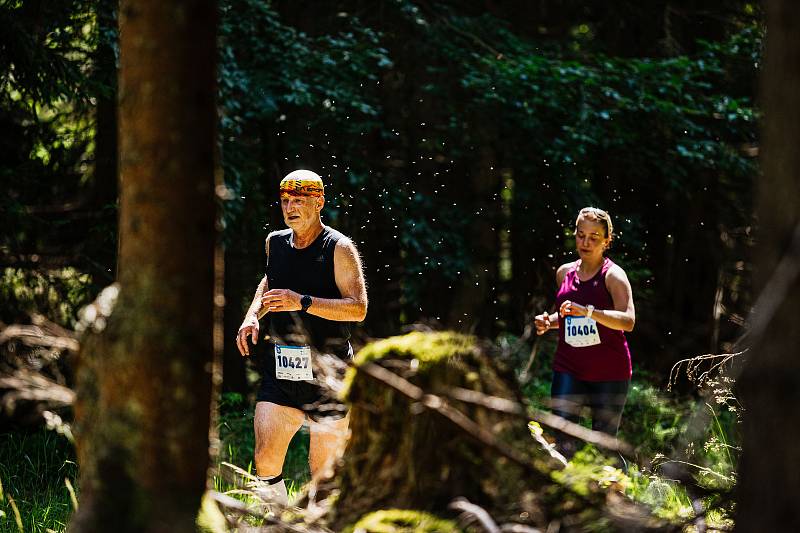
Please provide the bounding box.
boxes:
[334,332,548,529]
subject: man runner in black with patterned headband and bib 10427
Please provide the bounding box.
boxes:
[236,170,367,505]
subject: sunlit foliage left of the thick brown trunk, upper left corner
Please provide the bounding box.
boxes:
[0,0,116,281]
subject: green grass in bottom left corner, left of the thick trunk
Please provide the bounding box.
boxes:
[0,429,78,533]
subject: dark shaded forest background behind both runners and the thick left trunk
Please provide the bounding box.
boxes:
[0,0,762,390]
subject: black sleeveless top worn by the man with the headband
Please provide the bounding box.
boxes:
[264,226,351,357]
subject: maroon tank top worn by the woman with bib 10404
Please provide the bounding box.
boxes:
[553,257,631,381]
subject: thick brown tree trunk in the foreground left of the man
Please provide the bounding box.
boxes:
[70,0,222,532]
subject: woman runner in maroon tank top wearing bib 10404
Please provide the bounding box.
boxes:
[534,207,636,453]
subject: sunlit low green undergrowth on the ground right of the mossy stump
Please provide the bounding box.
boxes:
[526,370,740,524]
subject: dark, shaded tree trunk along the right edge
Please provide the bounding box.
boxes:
[736,0,800,531]
